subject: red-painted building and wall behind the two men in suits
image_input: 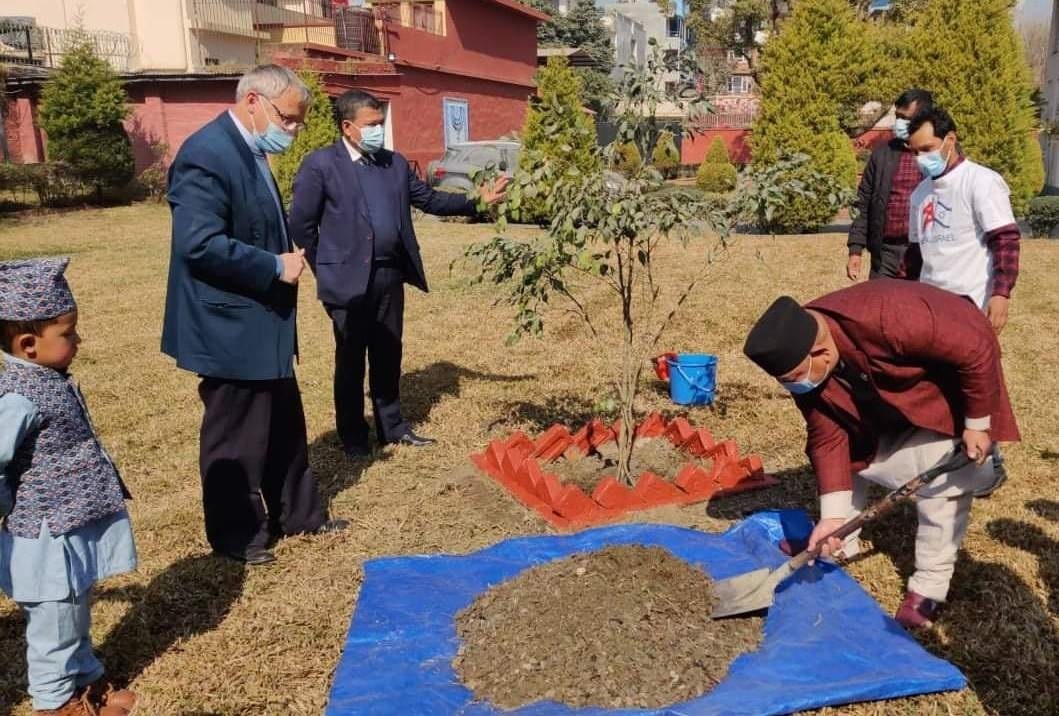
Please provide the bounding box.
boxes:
[4,0,546,175]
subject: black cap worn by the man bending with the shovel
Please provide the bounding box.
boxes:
[742,296,820,377]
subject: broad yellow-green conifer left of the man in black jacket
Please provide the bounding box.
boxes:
[751,0,882,229]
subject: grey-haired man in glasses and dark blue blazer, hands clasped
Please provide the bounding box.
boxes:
[162,65,347,565]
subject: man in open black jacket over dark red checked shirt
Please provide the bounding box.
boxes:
[846,89,934,281]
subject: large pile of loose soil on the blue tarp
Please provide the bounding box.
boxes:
[454,545,762,709]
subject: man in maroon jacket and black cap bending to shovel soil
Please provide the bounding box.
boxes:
[743,279,1019,628]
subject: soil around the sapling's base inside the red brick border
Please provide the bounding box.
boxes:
[544,437,699,495]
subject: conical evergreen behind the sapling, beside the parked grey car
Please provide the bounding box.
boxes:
[520,57,599,221]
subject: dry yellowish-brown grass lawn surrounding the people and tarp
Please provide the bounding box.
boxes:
[0,205,1059,716]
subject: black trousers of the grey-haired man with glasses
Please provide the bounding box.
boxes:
[199,377,326,554]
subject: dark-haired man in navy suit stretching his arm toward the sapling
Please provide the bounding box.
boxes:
[290,90,507,457]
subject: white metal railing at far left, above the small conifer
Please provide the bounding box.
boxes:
[0,22,133,72]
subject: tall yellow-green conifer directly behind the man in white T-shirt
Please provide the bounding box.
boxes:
[909,0,1044,214]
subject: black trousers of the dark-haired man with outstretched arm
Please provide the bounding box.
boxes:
[326,266,409,449]
